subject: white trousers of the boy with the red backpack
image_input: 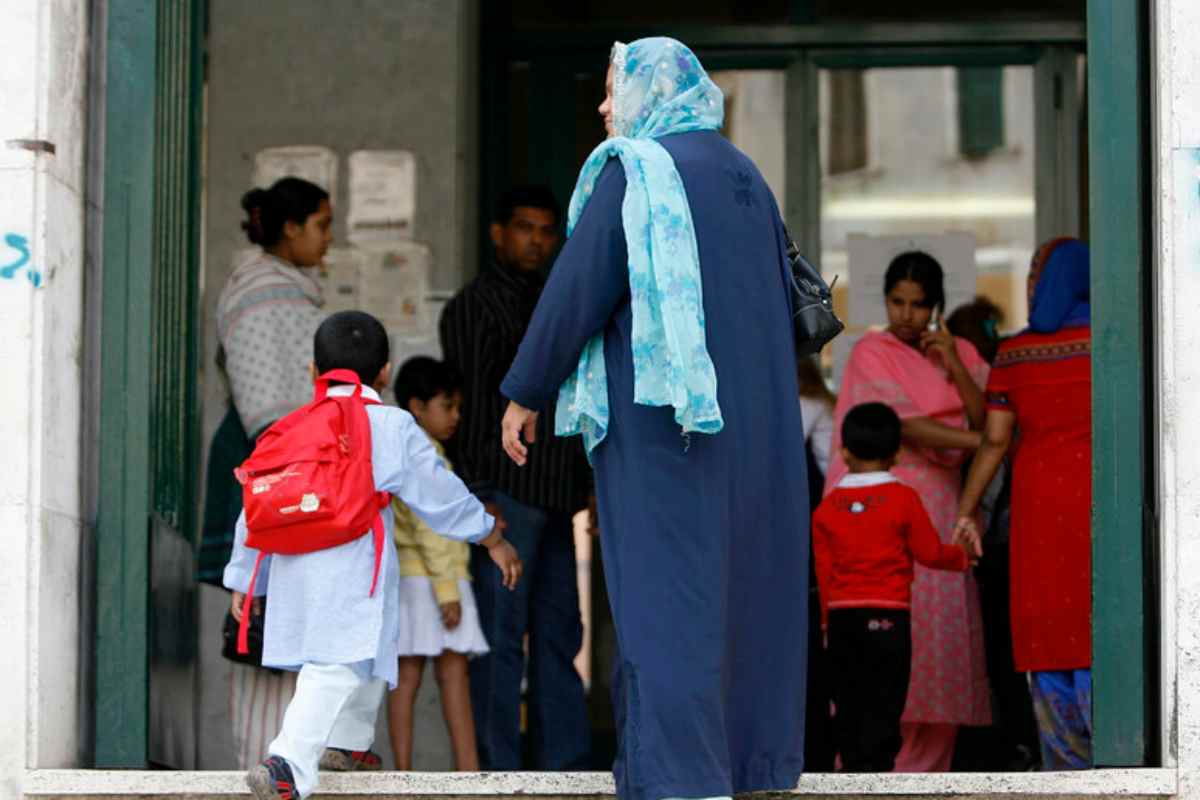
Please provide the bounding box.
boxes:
[268,662,386,798]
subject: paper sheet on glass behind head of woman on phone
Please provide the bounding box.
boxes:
[846,233,976,327]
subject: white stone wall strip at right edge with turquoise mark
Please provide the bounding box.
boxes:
[1151,0,1200,798]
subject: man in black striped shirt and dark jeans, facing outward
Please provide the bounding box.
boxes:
[440,186,590,770]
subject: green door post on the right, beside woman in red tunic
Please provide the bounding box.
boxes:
[1087,0,1160,766]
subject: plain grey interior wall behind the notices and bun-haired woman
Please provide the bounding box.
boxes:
[199,0,479,769]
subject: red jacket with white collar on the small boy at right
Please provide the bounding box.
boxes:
[812,473,967,622]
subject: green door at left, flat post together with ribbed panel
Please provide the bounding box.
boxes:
[95,0,204,769]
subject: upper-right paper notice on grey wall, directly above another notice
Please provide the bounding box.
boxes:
[347,150,416,241]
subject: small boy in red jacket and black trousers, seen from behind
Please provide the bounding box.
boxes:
[812,403,978,772]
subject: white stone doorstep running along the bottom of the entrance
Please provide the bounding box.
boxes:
[23,769,1178,798]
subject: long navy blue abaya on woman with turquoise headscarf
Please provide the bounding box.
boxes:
[502,131,809,800]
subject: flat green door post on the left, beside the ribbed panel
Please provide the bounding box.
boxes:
[95,0,157,768]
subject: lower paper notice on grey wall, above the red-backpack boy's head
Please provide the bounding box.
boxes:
[358,240,433,338]
